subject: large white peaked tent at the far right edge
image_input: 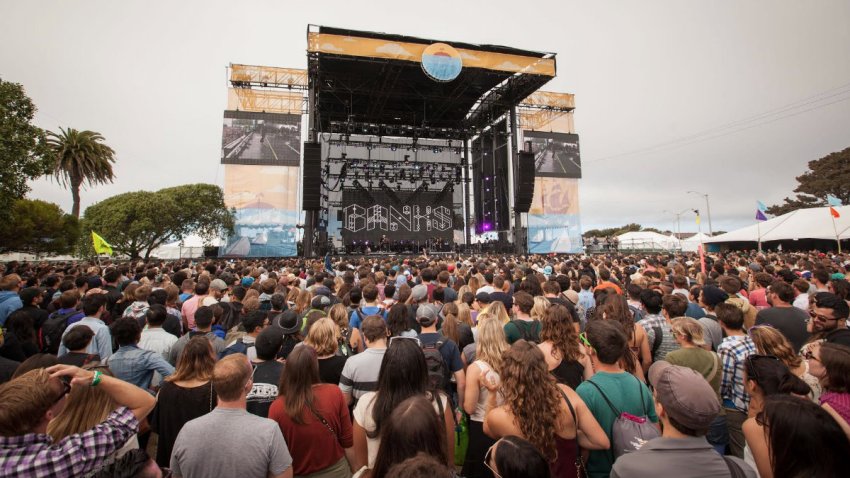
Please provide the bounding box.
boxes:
[705,206,850,243]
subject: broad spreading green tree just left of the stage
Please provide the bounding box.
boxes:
[81,184,234,259]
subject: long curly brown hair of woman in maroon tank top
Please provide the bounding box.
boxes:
[500,339,561,461]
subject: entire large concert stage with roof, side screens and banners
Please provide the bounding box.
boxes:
[222,26,581,256]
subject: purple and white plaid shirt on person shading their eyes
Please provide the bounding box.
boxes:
[0,407,139,478]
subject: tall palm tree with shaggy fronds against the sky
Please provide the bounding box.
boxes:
[47,128,115,218]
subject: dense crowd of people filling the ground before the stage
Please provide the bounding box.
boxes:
[0,251,850,478]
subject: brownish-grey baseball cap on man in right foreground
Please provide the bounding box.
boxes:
[649,360,720,430]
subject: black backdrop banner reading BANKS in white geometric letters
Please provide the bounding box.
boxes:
[340,188,454,246]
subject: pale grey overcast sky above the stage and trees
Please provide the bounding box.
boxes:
[0,0,850,231]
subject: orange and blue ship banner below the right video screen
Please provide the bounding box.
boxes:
[528,177,582,254]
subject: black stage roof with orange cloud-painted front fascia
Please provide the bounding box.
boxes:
[307,25,556,138]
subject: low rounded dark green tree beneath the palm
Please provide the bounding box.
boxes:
[0,199,80,255]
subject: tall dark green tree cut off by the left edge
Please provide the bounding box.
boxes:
[0,79,51,222]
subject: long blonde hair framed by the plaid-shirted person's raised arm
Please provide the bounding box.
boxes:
[47,366,116,443]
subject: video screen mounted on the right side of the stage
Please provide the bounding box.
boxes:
[523,131,581,178]
